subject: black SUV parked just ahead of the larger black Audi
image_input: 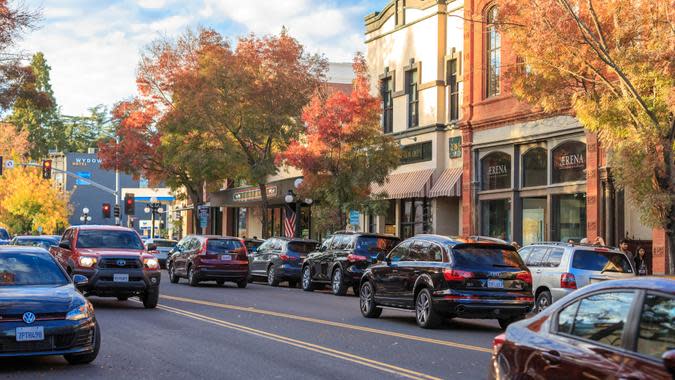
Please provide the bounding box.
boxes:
[302,232,400,296]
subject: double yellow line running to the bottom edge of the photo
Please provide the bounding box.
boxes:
[157,305,440,380]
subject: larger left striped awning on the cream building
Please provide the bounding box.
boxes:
[370,169,434,199]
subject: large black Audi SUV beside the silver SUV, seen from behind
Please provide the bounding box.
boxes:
[360,235,534,328]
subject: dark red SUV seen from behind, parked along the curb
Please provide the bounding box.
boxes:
[167,235,248,288]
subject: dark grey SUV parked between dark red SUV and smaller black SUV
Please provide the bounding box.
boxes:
[249,237,319,288]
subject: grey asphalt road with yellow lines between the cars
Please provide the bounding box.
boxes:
[0,276,501,379]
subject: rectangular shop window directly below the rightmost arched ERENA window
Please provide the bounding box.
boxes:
[551,193,586,242]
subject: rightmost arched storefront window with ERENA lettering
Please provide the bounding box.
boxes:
[551,141,586,183]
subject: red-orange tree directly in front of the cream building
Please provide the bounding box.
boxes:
[278,54,400,233]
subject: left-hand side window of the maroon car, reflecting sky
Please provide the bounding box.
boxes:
[570,292,635,347]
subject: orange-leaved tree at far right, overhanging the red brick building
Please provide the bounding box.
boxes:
[500,0,675,273]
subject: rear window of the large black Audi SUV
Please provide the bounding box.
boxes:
[452,247,525,270]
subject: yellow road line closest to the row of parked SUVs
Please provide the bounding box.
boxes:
[160,295,492,354]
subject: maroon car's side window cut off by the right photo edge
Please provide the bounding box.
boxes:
[637,294,675,359]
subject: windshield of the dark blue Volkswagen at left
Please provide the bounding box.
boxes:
[0,253,68,287]
